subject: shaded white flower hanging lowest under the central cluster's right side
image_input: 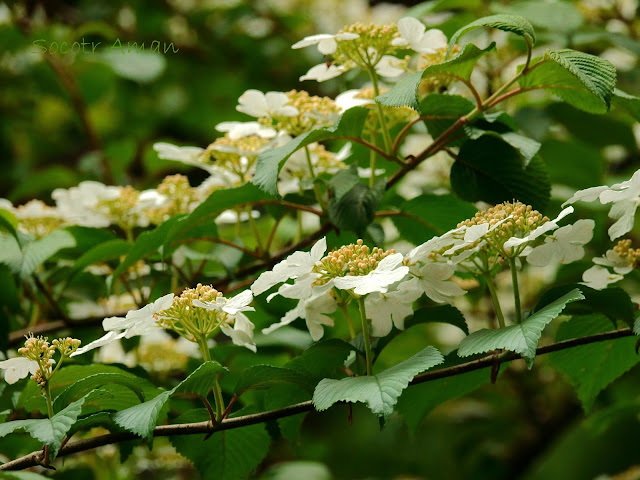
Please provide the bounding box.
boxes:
[364,283,422,337]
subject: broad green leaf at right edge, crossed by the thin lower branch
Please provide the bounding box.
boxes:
[550,315,640,413]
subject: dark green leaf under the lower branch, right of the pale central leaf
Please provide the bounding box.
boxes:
[396,352,491,433]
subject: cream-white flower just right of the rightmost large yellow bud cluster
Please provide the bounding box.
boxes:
[527,219,595,267]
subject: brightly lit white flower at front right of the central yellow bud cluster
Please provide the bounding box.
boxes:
[334,253,409,295]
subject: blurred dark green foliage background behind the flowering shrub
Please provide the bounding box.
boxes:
[0,0,640,480]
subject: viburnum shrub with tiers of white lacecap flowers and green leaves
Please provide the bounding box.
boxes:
[0,10,640,479]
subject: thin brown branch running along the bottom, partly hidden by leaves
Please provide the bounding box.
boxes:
[0,328,633,471]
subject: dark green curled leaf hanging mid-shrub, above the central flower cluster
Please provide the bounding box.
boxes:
[329,179,386,235]
